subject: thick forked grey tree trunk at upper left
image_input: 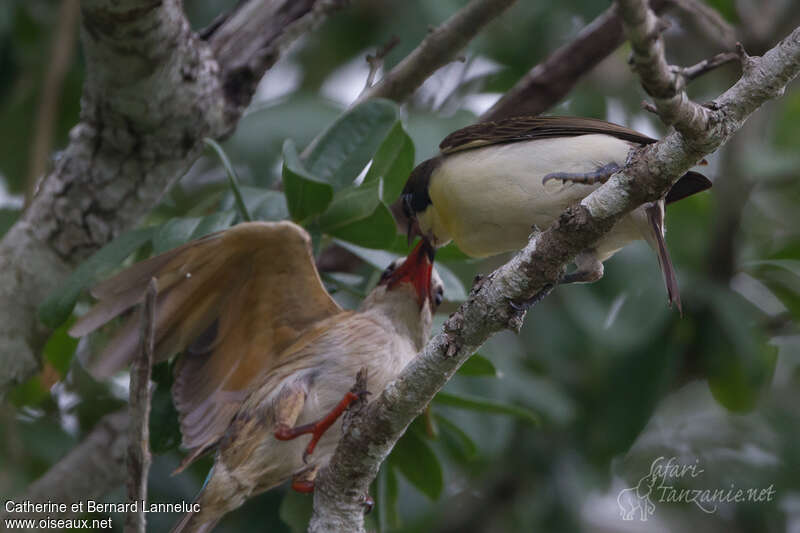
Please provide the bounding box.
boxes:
[0,0,347,399]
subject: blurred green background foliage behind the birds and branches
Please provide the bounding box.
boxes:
[0,0,800,532]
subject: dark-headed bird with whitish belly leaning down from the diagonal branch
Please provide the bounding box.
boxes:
[400,116,711,311]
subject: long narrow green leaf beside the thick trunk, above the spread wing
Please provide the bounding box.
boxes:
[39,227,156,328]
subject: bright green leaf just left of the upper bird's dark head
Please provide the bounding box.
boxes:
[364,121,414,205]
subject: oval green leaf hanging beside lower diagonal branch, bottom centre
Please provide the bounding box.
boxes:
[389,431,444,500]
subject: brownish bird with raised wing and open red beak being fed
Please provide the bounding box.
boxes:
[70,221,443,532]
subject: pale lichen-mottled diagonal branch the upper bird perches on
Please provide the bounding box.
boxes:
[309,20,800,533]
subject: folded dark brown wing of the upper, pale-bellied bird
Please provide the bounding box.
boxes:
[439,116,656,154]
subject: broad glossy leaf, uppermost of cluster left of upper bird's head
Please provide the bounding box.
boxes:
[305,99,399,191]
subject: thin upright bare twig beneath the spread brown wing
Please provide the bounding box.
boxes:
[125,278,158,533]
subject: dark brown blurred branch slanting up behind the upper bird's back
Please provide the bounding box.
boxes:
[481,0,672,121]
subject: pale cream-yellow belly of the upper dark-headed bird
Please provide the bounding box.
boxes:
[423,135,641,257]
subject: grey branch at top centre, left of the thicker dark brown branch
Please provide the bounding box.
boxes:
[359,0,516,102]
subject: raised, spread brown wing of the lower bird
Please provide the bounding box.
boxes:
[70,222,342,464]
